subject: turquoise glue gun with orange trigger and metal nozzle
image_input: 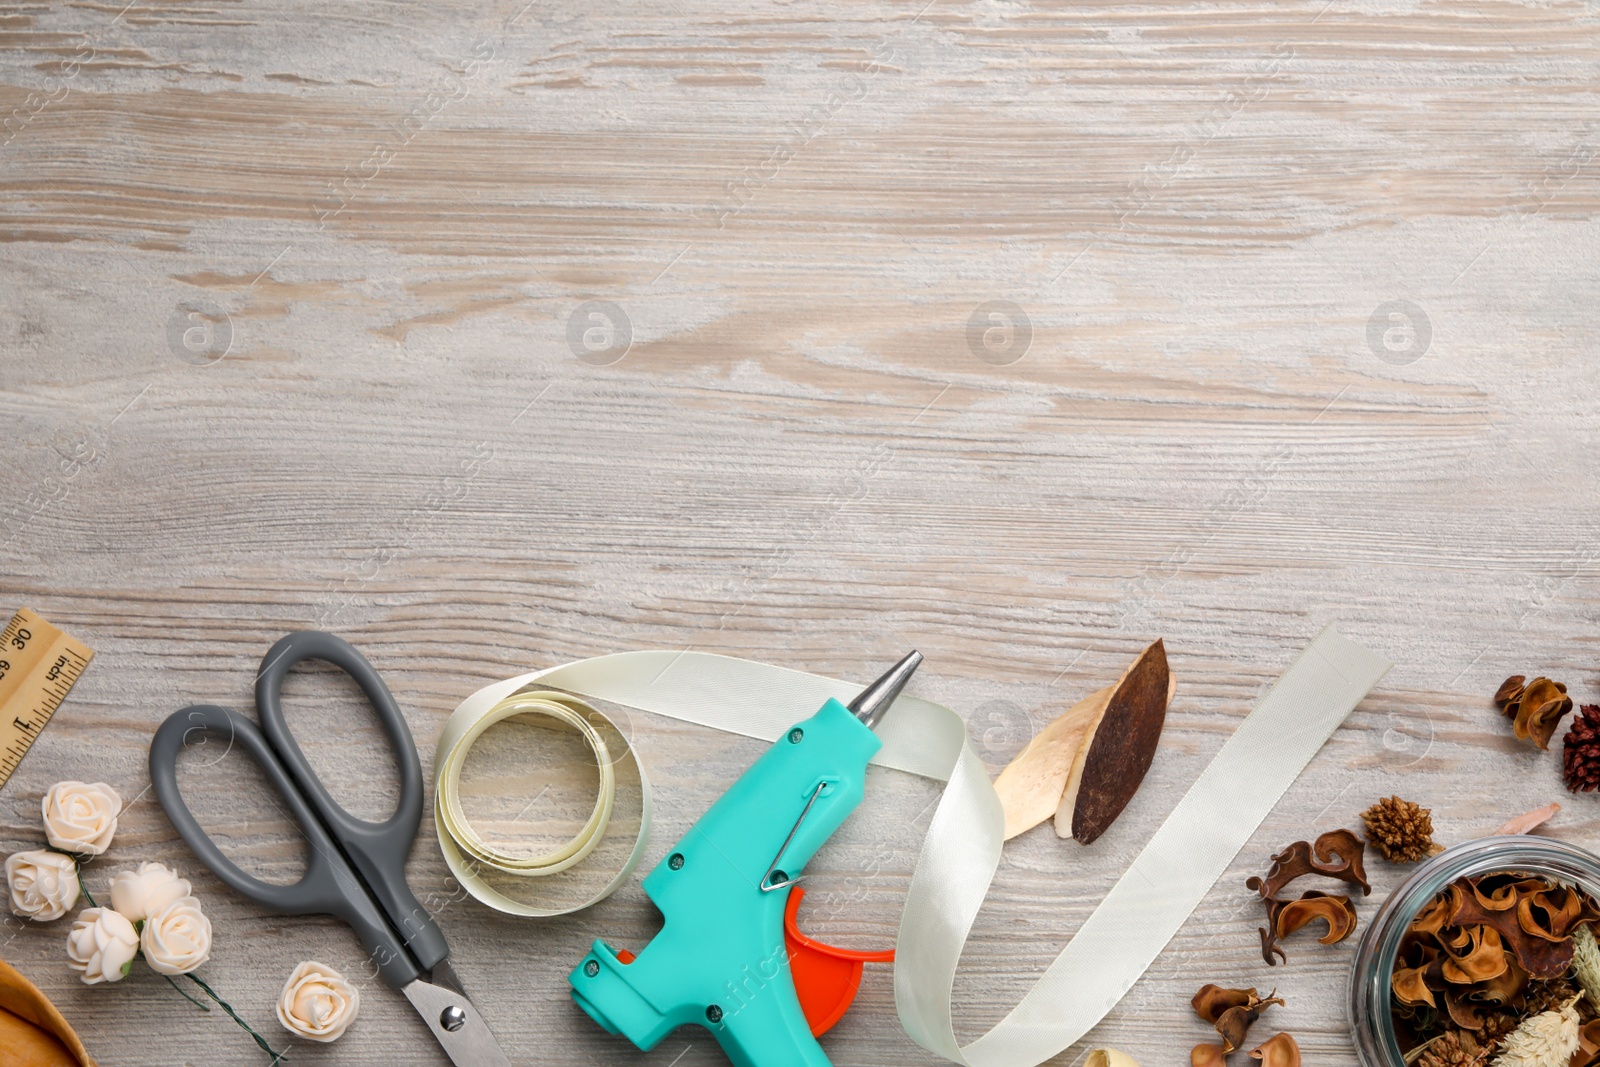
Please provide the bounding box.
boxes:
[568,653,922,1067]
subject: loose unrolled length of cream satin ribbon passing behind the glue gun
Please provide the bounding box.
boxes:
[440,627,1392,1067]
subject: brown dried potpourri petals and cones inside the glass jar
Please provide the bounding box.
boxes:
[1390,870,1600,1067]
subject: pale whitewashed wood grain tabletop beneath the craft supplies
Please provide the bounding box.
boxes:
[0,0,1600,1067]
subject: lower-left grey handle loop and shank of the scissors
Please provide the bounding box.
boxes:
[150,704,421,989]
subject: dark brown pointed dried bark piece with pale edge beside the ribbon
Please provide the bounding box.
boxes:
[1056,640,1171,845]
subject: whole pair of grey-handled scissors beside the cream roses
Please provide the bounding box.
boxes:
[150,630,510,1067]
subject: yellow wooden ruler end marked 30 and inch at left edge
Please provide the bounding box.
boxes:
[0,608,94,787]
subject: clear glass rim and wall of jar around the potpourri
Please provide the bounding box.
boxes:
[1350,835,1600,1067]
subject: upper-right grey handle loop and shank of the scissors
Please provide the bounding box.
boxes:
[256,630,450,971]
